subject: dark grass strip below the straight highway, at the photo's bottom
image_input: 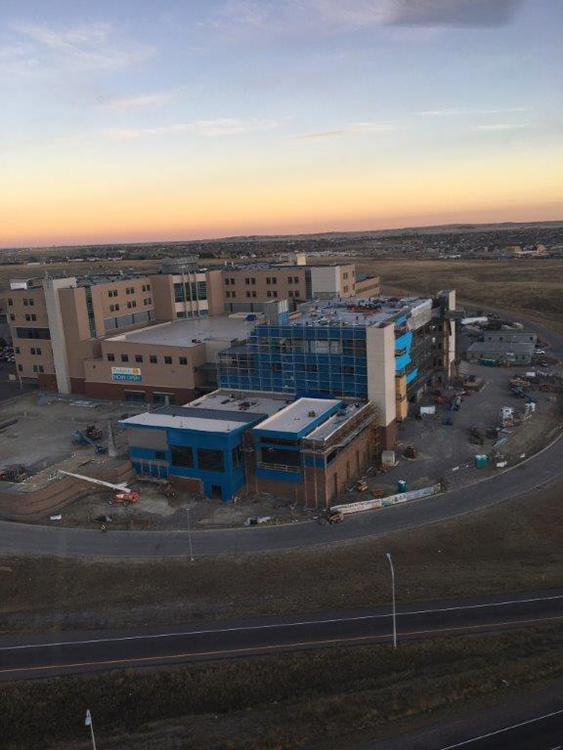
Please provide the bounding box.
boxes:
[0,626,563,750]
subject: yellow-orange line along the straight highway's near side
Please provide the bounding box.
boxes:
[0,615,563,680]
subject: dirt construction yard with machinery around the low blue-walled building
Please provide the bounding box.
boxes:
[0,338,563,530]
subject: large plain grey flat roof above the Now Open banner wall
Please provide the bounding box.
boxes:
[106,315,253,347]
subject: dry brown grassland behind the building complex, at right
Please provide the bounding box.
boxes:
[357,259,563,331]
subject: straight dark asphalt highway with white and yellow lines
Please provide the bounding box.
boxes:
[0,589,563,680]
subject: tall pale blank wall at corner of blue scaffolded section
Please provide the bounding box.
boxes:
[366,325,397,427]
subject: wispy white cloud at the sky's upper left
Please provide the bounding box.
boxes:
[0,23,154,74]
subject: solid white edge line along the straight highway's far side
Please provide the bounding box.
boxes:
[0,594,563,652]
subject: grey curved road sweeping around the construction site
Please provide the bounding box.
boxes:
[0,314,563,558]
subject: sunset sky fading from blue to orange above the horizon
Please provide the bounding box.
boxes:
[0,0,563,247]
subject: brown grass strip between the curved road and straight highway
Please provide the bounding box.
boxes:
[0,482,563,632]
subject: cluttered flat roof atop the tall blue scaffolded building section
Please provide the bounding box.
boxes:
[292,297,432,326]
